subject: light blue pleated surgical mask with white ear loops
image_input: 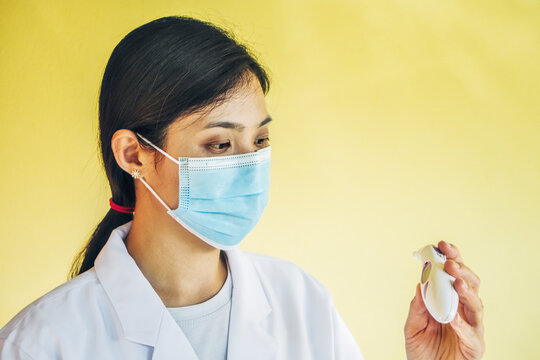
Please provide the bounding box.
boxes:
[133,133,270,250]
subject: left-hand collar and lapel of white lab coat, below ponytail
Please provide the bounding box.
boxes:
[95,221,198,360]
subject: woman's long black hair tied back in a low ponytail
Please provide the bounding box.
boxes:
[68,16,270,278]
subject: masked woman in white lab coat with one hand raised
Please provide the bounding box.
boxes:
[0,17,483,360]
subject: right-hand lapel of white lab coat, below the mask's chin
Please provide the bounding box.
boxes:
[225,247,277,360]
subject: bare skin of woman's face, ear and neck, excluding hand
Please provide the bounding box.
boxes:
[111,72,270,307]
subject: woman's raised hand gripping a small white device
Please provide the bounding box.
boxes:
[404,241,486,360]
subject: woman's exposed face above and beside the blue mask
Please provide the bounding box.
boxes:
[143,76,271,209]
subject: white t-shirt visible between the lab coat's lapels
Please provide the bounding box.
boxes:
[167,253,232,360]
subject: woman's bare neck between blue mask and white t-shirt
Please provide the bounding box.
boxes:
[124,197,227,307]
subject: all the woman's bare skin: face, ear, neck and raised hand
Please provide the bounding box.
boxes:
[111,69,485,360]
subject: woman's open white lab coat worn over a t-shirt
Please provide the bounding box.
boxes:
[0,221,363,360]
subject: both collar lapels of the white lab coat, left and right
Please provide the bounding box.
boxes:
[95,221,277,360]
